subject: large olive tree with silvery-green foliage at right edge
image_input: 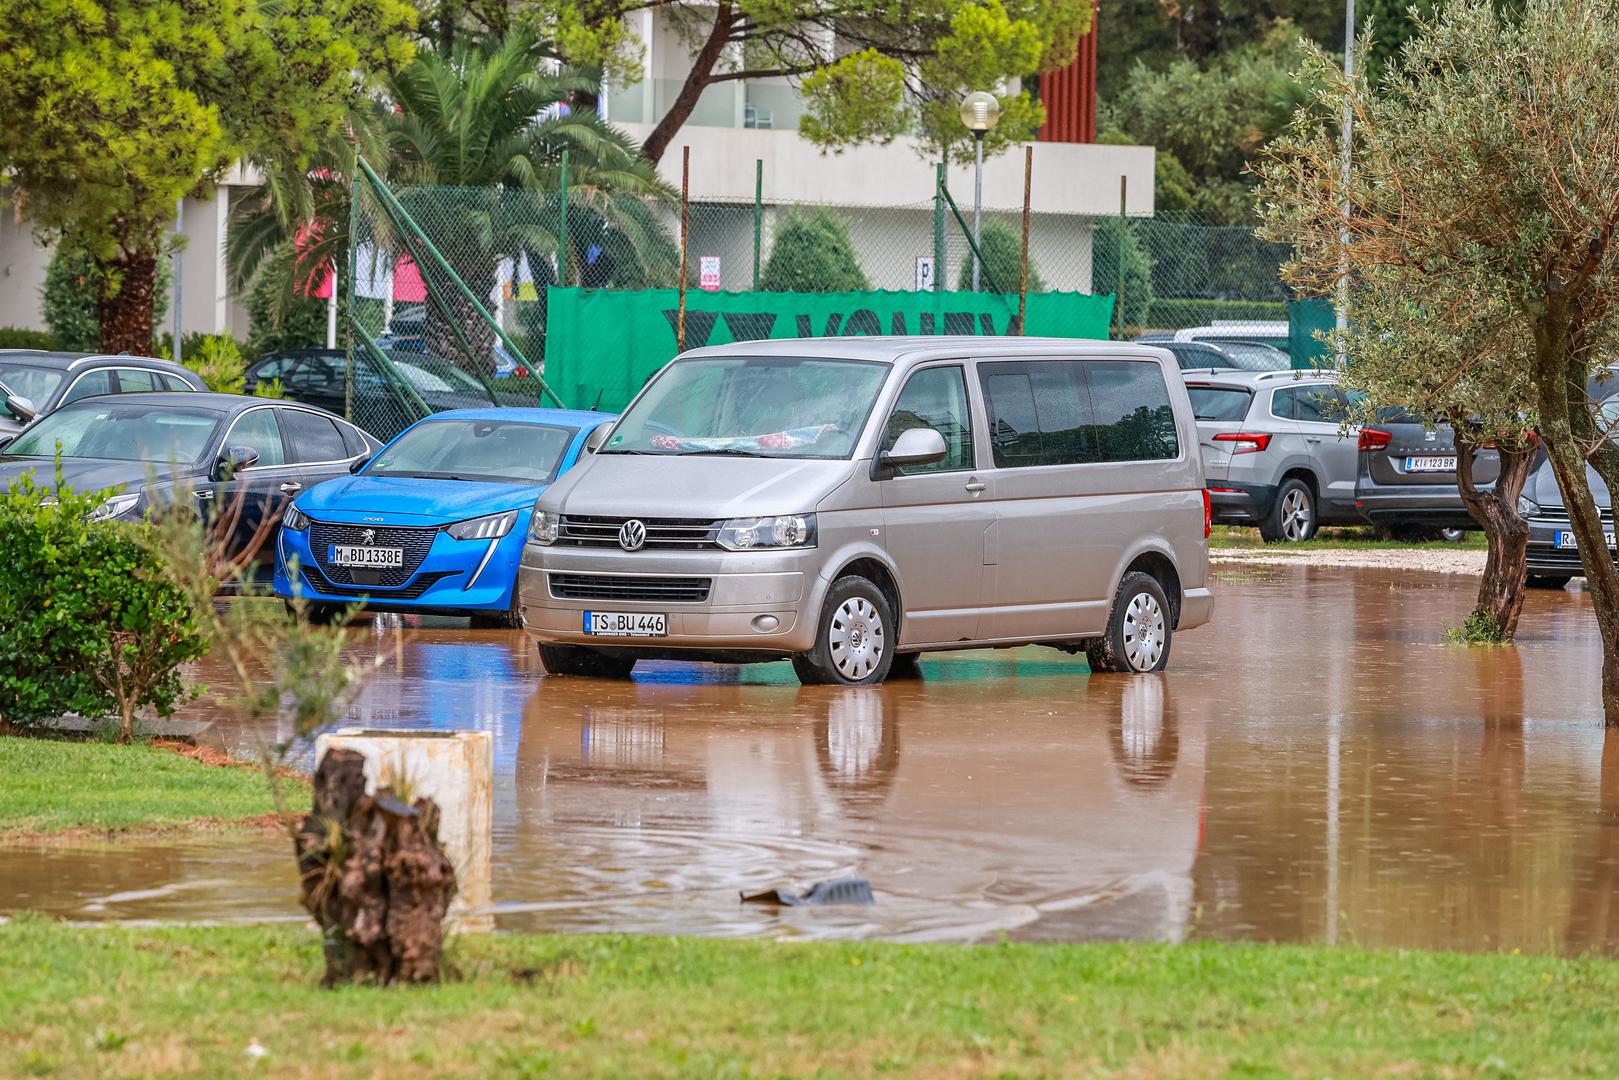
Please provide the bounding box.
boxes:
[1260,0,1619,725]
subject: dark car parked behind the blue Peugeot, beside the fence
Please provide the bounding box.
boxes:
[244,348,534,440]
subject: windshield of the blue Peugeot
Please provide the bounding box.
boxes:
[364,419,578,484]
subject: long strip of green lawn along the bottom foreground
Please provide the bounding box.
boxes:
[0,918,1619,1078]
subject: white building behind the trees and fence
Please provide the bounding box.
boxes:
[0,8,1153,338]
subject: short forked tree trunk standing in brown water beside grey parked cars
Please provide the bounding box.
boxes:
[1455,427,1535,641]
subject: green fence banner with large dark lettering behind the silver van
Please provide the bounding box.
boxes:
[546,287,1112,410]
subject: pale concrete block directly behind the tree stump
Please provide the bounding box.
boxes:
[314,727,494,931]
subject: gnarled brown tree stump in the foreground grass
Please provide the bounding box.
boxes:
[295,750,455,986]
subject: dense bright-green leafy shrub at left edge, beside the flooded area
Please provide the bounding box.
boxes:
[0,473,206,740]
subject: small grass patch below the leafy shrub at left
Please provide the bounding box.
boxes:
[0,737,281,841]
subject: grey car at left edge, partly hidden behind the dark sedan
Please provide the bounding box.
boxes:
[0,348,207,436]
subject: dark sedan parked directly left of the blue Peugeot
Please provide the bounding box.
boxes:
[0,392,379,580]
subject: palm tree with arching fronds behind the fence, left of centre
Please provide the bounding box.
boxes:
[227,34,678,368]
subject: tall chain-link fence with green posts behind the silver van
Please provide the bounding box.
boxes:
[338,156,1318,437]
